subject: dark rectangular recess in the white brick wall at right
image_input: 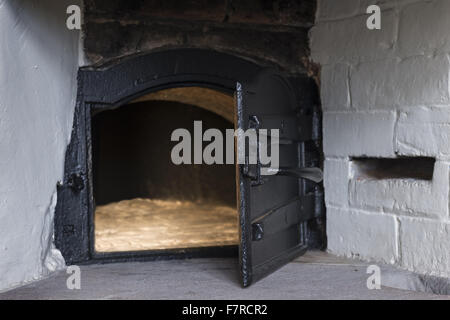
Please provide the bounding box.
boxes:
[351,157,436,181]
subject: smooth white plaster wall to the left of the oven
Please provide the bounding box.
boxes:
[0,0,80,290]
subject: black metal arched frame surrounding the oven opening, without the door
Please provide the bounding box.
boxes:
[55,49,324,264]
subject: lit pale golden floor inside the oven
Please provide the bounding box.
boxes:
[95,198,238,252]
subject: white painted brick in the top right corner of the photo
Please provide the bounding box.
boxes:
[398,0,450,57]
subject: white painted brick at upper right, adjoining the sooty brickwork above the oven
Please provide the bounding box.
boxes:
[310,11,397,65]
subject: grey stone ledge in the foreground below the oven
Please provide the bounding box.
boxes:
[0,252,450,300]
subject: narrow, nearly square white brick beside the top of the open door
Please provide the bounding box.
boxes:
[320,64,350,110]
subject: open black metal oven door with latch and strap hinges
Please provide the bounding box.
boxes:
[235,70,320,286]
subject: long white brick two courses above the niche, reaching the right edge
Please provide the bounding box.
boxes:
[350,55,450,109]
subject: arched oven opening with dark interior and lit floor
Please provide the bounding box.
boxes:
[91,87,238,253]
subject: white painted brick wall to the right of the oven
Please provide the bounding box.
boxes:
[310,0,450,277]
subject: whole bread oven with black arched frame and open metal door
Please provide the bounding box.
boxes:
[55,49,323,285]
